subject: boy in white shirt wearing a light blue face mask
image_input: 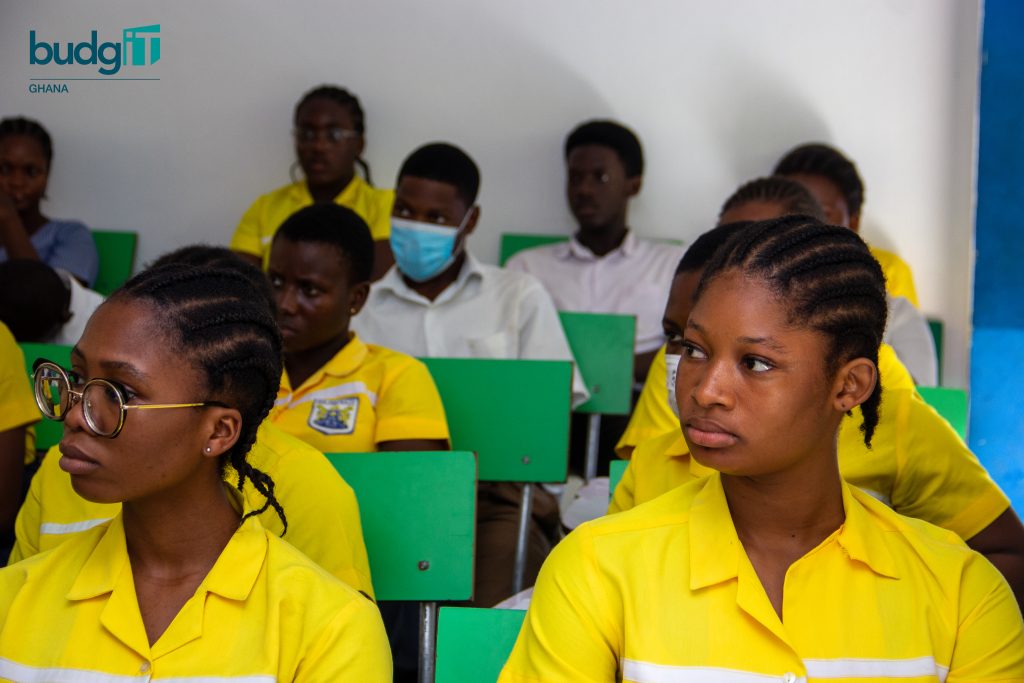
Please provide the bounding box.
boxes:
[352,142,588,607]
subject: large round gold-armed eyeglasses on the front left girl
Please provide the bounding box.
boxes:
[33,358,225,438]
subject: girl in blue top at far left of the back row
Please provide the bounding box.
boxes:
[0,117,99,287]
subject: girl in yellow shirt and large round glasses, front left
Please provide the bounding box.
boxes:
[0,260,391,681]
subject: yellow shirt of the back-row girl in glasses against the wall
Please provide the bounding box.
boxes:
[230,176,394,266]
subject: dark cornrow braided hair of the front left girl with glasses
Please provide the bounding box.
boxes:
[111,263,288,531]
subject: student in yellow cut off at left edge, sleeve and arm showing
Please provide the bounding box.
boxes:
[0,323,39,561]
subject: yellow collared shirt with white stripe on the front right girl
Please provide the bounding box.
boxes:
[499,473,1024,683]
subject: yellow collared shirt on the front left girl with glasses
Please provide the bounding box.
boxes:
[0,514,391,683]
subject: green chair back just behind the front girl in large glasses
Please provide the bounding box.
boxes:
[327,451,476,602]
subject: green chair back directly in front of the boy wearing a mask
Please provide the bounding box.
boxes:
[421,358,572,482]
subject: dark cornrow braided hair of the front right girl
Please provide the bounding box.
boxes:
[694,216,887,447]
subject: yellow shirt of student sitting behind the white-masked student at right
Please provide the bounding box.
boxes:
[615,344,914,458]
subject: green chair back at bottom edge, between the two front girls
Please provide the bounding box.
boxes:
[434,607,526,683]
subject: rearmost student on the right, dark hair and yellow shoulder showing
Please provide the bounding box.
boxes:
[772,143,921,306]
